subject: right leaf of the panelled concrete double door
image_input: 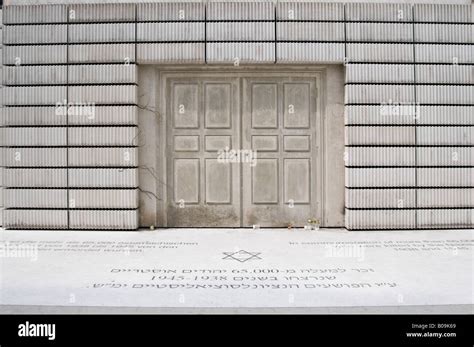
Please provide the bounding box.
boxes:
[242,78,319,227]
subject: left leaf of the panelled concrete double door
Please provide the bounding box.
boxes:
[167,77,241,227]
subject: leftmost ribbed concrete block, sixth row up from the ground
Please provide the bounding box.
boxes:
[0,106,66,126]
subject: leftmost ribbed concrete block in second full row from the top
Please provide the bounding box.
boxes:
[3,24,67,45]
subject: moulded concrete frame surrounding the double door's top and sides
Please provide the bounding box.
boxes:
[155,65,326,227]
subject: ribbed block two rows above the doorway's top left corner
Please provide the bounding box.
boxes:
[137,22,205,42]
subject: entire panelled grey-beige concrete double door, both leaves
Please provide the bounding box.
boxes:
[165,75,321,227]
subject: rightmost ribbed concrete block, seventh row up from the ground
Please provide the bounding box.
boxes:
[416,85,474,105]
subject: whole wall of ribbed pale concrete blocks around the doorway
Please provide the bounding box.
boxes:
[0,1,474,230]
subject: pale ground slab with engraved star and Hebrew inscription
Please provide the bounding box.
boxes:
[0,229,474,314]
